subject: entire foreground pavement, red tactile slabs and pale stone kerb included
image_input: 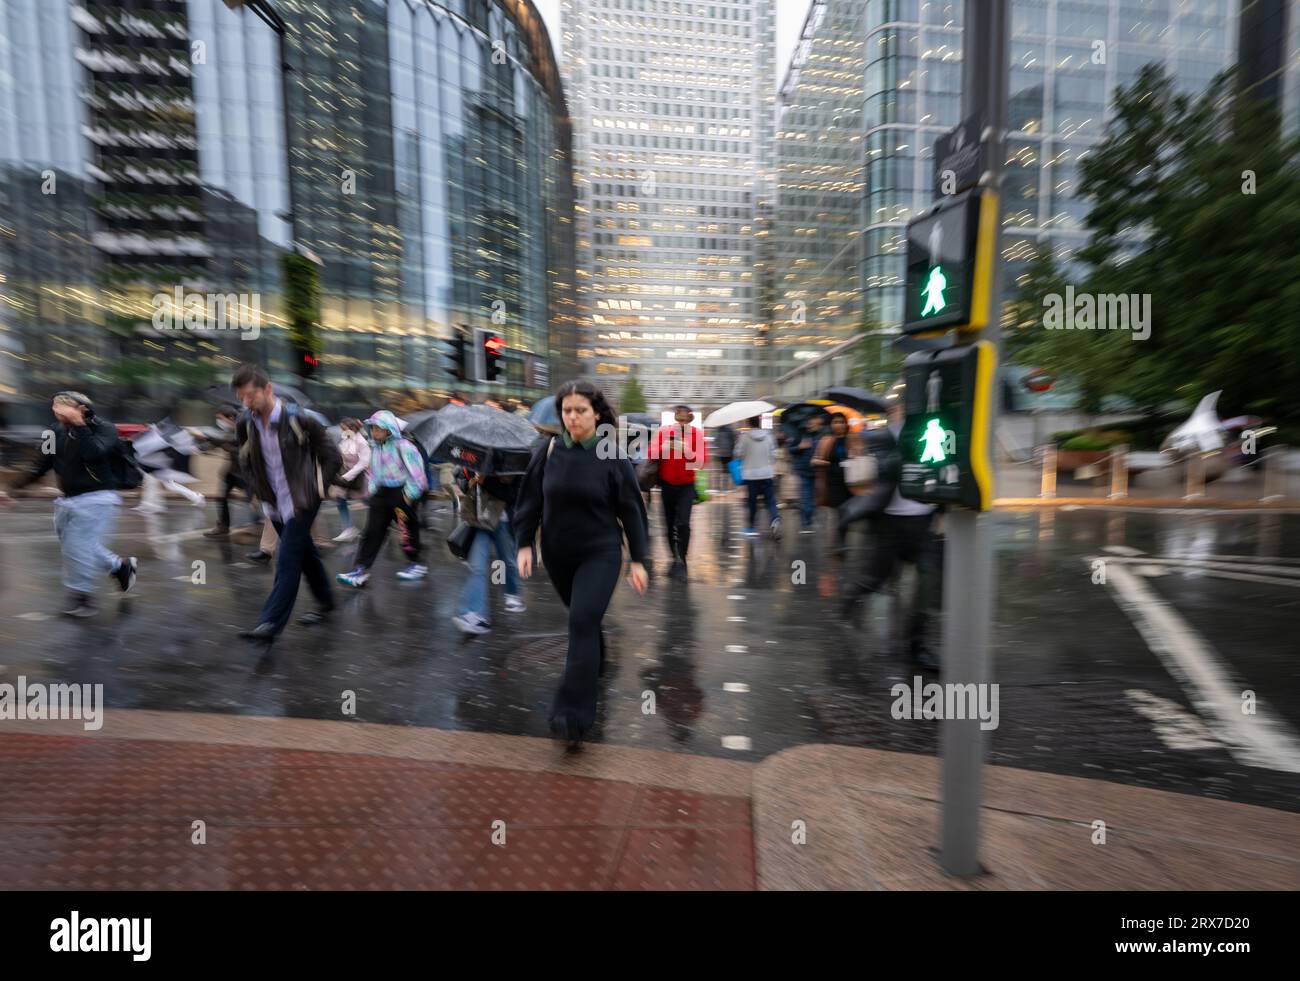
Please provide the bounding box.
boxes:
[0,709,1300,890]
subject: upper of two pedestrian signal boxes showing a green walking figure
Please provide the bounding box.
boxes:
[902,187,997,334]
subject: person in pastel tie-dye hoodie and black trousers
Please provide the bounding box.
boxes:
[338,409,429,586]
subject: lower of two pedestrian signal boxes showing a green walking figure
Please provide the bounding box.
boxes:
[898,340,997,511]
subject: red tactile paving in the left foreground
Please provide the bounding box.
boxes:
[0,734,755,890]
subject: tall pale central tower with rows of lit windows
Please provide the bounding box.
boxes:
[562,0,775,405]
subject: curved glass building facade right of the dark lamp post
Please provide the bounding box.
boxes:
[278,0,573,394]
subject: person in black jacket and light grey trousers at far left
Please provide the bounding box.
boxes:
[0,391,138,617]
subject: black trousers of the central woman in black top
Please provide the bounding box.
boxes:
[545,551,623,732]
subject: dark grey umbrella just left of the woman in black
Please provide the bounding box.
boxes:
[404,405,537,476]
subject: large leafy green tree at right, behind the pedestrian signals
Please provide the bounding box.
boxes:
[1008,65,1300,420]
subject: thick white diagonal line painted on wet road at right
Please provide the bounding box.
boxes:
[1106,563,1300,773]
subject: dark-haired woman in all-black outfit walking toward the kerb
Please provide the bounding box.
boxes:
[515,381,650,750]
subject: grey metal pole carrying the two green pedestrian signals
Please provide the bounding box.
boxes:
[940,0,1009,876]
